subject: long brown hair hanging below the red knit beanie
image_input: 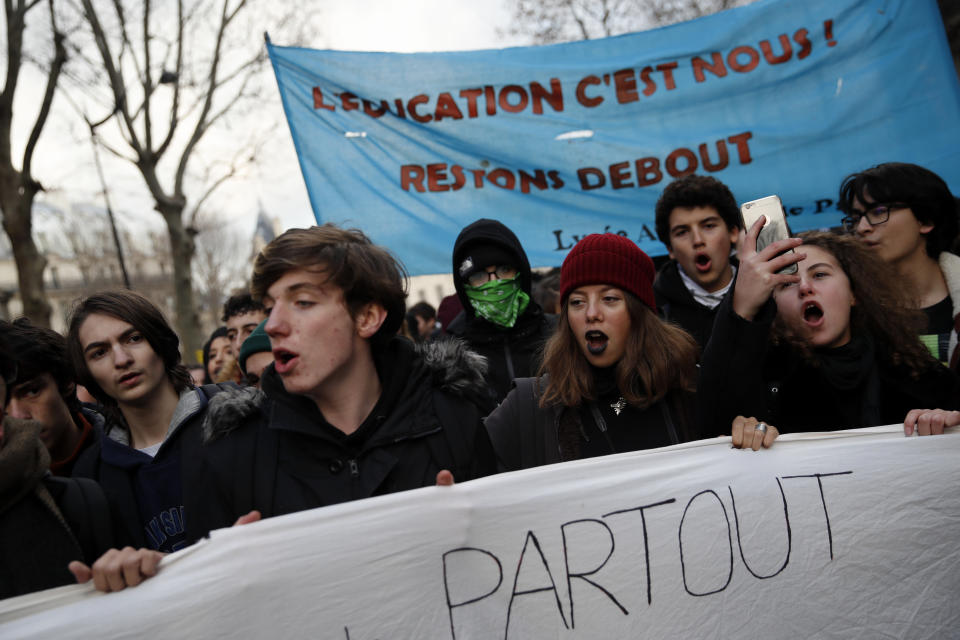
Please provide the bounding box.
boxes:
[538,291,698,409]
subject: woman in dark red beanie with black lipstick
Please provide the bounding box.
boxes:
[486,233,697,470]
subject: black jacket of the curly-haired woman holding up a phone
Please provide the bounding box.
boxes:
[697,295,960,434]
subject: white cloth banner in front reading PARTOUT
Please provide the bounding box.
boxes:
[0,427,960,640]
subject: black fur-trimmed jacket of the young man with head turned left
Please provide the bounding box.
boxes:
[184,338,496,541]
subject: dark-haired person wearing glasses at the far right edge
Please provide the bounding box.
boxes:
[838,162,960,371]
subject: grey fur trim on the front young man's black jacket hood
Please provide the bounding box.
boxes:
[202,338,487,444]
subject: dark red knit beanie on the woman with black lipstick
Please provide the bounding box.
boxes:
[560,233,657,313]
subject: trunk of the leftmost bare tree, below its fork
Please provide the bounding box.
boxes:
[0,171,50,327]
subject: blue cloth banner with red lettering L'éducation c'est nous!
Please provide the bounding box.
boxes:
[268,0,960,275]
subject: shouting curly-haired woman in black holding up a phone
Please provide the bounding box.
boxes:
[697,217,960,450]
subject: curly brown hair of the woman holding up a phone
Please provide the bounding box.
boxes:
[773,231,939,377]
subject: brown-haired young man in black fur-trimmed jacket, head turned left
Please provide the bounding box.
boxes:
[187,224,495,539]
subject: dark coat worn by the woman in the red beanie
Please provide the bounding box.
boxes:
[484,376,697,471]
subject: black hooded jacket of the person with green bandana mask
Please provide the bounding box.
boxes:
[447,218,557,408]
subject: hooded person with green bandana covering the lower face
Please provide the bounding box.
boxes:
[447,219,557,409]
